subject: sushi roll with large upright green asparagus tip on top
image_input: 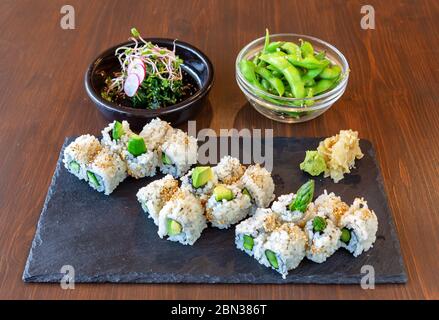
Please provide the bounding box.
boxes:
[271,180,314,224]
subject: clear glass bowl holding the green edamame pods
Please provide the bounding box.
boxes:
[235,33,349,123]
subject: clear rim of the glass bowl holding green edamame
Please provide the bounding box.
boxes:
[235,33,349,111]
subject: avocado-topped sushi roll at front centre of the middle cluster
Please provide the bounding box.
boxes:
[206,184,251,229]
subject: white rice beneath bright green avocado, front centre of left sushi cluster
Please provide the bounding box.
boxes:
[122,150,159,179]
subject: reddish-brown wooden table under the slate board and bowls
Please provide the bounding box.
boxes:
[0,0,439,299]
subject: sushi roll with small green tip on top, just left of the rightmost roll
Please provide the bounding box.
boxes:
[305,215,341,263]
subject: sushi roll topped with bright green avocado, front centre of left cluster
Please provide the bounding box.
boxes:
[122,134,158,179]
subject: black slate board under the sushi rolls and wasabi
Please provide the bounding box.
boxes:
[23,138,407,284]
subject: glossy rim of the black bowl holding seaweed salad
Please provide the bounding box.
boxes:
[84,38,214,118]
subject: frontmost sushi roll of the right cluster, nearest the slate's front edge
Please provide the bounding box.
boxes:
[255,222,307,279]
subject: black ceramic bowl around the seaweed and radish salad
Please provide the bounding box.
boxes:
[84,38,213,129]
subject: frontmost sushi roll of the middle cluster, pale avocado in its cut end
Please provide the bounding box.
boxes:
[158,190,207,245]
